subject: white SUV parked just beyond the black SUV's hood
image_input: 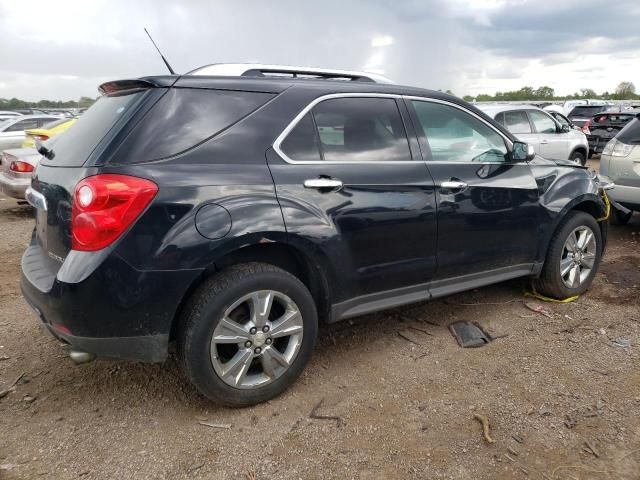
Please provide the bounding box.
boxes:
[476,103,589,165]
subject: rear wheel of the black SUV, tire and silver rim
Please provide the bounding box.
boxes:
[177,263,318,407]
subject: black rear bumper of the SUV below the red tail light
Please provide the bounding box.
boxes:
[21,243,199,362]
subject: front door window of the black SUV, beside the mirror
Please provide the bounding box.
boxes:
[412,100,508,162]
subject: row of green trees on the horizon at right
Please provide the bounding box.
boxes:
[460,82,640,102]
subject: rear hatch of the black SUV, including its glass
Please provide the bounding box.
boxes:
[32,81,166,265]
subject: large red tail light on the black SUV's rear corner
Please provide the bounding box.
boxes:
[71,174,158,251]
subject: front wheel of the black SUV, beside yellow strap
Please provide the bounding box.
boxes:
[534,211,602,299]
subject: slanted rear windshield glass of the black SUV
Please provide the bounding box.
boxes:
[42,90,143,167]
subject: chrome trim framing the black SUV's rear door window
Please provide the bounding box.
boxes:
[273,93,422,165]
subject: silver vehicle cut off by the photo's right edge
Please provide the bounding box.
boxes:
[600,118,640,224]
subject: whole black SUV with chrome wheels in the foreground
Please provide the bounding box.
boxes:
[22,66,606,406]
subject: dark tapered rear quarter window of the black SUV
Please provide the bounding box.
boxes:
[124,88,274,163]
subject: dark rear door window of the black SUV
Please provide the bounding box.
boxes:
[281,97,411,162]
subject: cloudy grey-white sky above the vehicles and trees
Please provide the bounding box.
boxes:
[0,0,640,100]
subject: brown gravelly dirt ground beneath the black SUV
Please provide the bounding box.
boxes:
[0,164,640,480]
